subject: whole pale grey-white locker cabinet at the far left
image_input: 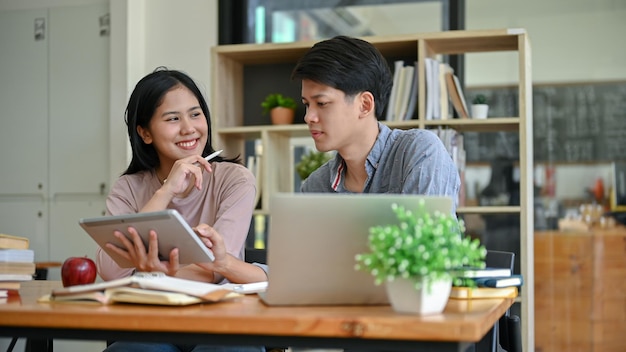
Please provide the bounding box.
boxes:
[0,1,109,261]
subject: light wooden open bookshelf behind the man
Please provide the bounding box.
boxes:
[210,29,534,349]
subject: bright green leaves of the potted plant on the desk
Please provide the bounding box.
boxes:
[356,201,487,285]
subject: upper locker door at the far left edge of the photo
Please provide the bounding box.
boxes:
[0,10,48,195]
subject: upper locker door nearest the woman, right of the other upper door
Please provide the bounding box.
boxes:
[48,4,108,198]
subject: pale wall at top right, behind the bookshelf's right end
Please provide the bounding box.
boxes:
[466,0,626,86]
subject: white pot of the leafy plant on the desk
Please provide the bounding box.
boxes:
[385,278,452,315]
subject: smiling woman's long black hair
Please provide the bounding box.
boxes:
[123,67,241,175]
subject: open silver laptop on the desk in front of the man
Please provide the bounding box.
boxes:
[260,193,452,306]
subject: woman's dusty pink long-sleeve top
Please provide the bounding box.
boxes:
[96,162,256,281]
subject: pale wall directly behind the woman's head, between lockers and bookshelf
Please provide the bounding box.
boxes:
[110,0,218,181]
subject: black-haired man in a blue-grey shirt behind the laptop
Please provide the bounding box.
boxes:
[292,36,460,213]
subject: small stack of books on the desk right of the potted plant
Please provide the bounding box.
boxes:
[450,268,524,299]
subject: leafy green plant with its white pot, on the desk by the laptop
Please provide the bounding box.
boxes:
[356,200,487,314]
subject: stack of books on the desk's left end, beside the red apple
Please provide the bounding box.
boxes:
[0,234,35,297]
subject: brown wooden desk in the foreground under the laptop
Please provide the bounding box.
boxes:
[0,281,513,351]
